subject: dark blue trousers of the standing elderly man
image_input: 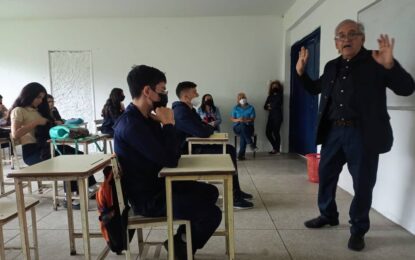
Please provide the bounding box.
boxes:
[318,126,379,236]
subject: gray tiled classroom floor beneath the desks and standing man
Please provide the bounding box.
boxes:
[5,153,415,260]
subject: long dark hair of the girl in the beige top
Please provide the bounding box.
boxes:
[8,82,52,123]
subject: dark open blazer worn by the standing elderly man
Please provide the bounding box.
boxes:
[300,48,415,153]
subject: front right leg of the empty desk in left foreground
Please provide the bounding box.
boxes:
[78,179,91,260]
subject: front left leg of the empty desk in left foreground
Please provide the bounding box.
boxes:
[14,179,31,260]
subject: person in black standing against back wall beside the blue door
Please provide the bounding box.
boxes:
[264,80,283,154]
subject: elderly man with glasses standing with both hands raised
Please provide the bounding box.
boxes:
[296,20,415,251]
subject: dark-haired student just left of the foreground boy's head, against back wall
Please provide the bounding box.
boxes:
[101,88,125,136]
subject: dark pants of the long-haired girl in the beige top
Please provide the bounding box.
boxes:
[22,144,97,192]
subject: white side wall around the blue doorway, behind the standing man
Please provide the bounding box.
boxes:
[283,0,415,234]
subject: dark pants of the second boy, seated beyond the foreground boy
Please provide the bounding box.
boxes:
[192,144,241,196]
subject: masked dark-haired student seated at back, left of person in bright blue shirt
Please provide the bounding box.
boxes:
[197,94,222,132]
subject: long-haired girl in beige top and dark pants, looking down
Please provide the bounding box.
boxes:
[8,82,96,209]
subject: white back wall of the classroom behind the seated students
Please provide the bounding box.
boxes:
[0,16,283,150]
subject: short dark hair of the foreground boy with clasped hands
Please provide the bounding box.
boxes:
[127,65,167,98]
